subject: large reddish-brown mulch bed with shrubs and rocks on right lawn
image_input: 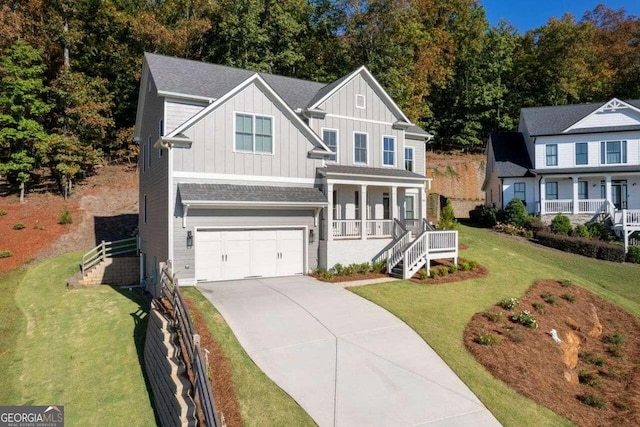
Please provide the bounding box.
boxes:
[464,280,640,426]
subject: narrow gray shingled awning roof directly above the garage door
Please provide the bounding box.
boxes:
[178,183,327,204]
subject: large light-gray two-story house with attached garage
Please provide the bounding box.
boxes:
[135,53,457,286]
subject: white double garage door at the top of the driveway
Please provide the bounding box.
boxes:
[195,230,304,281]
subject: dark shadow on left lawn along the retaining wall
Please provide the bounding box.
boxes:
[112,286,160,425]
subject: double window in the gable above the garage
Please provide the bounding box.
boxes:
[234,113,273,154]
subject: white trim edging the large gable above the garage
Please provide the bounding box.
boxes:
[168,73,330,151]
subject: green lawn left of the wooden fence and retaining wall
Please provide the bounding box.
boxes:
[0,254,156,426]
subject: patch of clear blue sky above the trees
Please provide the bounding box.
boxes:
[480,0,640,33]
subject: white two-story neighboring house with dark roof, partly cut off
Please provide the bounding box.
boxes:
[483,98,640,251]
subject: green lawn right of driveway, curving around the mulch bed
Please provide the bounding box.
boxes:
[350,226,640,426]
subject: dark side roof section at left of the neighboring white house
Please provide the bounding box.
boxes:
[489,132,535,178]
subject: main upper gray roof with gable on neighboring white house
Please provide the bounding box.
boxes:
[520,99,640,136]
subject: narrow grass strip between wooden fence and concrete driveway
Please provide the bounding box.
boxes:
[182,288,315,426]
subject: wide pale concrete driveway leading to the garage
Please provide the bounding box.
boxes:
[198,276,500,426]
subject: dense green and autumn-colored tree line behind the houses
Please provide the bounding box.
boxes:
[0,0,640,201]
